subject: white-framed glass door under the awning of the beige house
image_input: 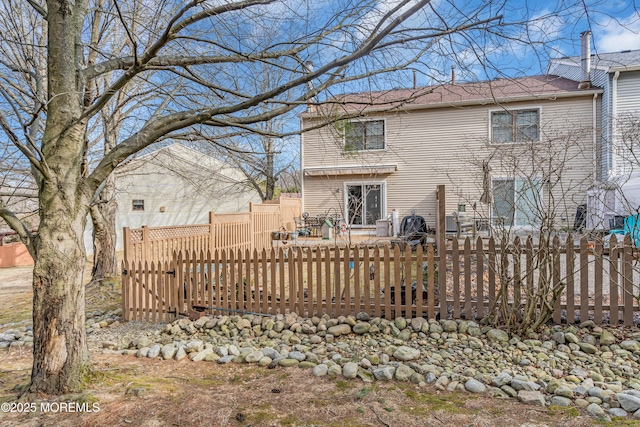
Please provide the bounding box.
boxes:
[347,184,382,226]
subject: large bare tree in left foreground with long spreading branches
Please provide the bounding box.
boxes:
[0,0,524,394]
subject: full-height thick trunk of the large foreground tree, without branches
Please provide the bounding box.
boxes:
[29,0,95,394]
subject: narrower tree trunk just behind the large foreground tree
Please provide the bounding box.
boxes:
[90,173,120,282]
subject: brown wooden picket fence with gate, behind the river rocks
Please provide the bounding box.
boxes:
[122,236,640,325]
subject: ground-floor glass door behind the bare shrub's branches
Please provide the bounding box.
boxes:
[493,178,541,227]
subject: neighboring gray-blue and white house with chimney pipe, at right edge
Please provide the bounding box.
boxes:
[548,31,640,228]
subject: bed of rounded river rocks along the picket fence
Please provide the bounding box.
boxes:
[25,311,640,420]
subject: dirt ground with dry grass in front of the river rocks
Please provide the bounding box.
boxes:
[0,266,640,427]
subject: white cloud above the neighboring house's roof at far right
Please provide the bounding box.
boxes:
[594,12,640,52]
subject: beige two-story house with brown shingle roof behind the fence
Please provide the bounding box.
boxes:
[301,75,602,234]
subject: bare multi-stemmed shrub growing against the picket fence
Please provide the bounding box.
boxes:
[450,115,595,334]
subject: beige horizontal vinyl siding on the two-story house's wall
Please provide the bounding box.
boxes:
[302,96,593,229]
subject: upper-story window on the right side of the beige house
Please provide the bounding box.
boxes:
[491,109,540,144]
